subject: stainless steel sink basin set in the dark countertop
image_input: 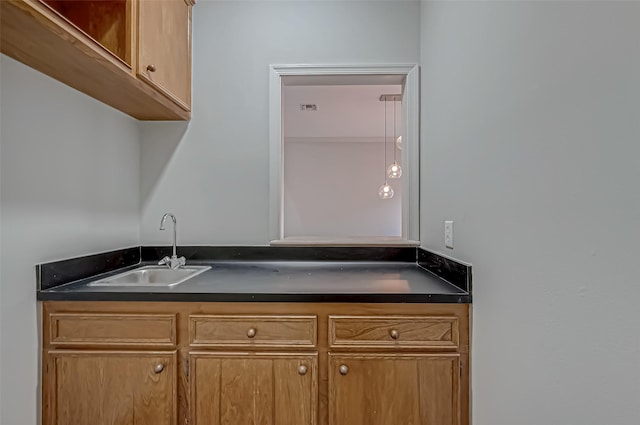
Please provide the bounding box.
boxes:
[88,266,211,286]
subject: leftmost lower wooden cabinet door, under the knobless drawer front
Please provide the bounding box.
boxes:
[43,351,177,425]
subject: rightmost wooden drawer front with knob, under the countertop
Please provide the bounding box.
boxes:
[329,316,459,349]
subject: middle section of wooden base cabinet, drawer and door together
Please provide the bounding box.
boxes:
[189,314,318,425]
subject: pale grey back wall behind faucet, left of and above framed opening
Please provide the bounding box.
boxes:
[141,1,420,245]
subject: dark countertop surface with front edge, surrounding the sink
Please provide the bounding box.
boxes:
[37,261,471,303]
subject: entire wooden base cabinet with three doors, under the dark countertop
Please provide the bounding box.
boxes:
[42,301,469,425]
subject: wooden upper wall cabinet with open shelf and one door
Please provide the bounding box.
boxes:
[0,0,195,120]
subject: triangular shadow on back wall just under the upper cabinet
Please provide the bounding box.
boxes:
[140,121,189,205]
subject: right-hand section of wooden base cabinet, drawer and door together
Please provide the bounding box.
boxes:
[328,314,467,425]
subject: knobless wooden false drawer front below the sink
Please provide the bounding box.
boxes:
[49,313,176,348]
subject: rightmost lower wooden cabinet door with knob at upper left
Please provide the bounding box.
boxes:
[329,354,460,425]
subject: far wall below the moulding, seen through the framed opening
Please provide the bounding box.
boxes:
[284,139,402,237]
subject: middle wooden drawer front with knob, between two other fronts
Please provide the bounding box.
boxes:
[189,315,317,347]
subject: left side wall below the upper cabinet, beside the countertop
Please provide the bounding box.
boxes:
[0,56,140,425]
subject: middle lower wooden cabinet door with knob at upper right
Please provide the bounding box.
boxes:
[189,353,318,425]
